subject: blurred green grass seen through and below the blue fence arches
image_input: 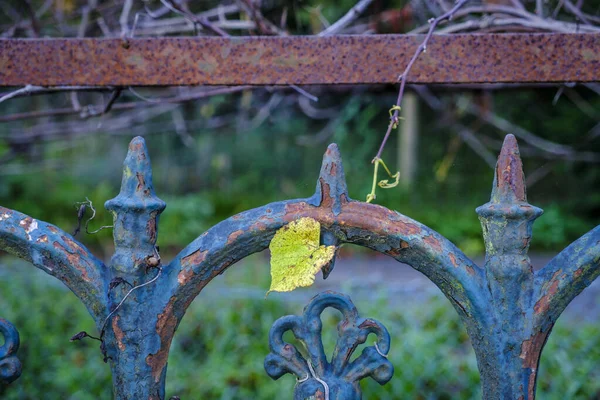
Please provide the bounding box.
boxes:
[0,259,600,400]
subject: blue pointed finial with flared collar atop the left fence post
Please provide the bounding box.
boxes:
[105,136,166,213]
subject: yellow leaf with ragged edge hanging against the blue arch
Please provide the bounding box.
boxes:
[267,218,335,295]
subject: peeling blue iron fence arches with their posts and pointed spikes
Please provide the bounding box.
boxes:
[0,135,600,400]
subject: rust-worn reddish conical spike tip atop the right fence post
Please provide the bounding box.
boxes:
[490,134,527,203]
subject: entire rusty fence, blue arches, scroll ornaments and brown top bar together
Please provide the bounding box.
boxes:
[0,35,600,400]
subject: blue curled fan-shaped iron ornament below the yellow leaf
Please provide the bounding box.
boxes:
[265,292,394,400]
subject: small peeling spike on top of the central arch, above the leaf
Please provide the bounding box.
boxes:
[312,143,350,215]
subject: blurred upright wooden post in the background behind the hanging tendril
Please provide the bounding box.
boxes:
[398,92,419,186]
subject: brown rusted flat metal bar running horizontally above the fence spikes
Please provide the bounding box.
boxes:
[0,33,600,86]
